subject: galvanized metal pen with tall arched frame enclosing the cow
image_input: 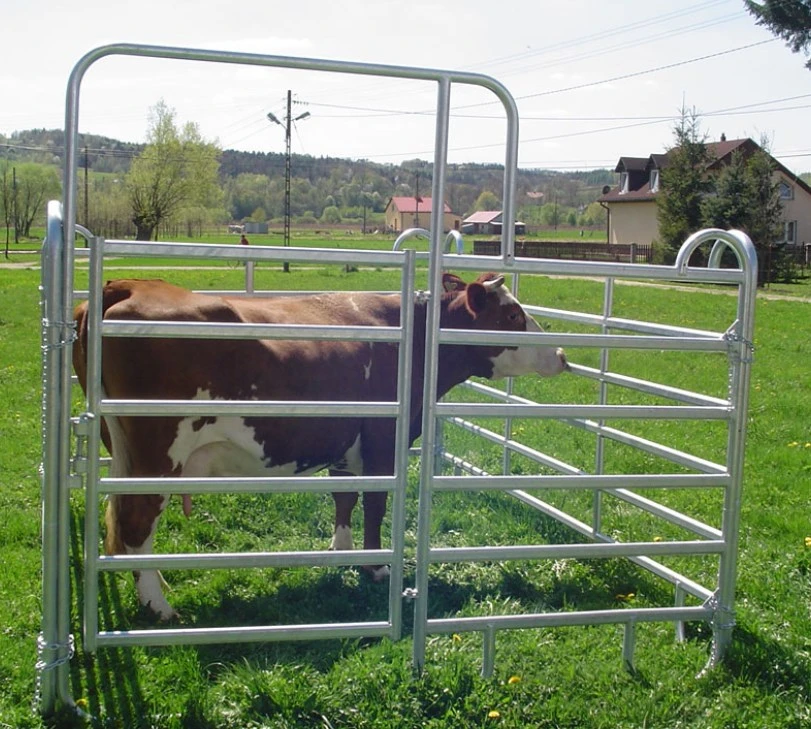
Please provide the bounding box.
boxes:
[37,45,756,713]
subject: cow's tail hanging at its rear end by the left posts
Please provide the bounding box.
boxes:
[73,287,132,554]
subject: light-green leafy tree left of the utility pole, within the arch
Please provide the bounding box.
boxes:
[126,100,220,240]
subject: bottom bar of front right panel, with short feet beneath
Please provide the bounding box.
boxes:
[428,606,713,634]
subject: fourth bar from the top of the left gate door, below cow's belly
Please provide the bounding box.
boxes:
[98,476,397,494]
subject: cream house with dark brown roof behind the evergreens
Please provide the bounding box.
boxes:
[598,137,811,245]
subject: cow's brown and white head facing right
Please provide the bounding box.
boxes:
[442,273,569,380]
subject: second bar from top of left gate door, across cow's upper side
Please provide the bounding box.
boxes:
[101,319,402,342]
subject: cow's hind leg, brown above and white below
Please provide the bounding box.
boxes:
[104,494,177,620]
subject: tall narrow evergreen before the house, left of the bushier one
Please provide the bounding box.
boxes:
[656,108,711,253]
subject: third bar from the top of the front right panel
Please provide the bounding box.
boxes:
[436,402,733,420]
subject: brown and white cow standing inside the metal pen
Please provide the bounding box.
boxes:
[73,274,567,619]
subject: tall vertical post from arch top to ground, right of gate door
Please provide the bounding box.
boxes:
[413,76,450,671]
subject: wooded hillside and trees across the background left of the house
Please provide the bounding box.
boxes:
[0,106,614,245]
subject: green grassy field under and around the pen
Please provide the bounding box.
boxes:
[0,249,811,729]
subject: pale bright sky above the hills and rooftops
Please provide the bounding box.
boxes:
[0,0,811,173]
